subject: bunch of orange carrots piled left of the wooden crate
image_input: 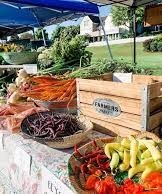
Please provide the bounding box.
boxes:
[21,76,76,105]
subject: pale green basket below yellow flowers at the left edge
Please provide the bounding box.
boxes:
[0,52,37,65]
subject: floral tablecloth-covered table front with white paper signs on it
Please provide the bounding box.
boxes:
[0,131,107,194]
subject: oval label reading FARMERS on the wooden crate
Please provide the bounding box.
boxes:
[93,98,121,117]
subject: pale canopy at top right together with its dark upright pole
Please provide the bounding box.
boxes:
[86,0,162,63]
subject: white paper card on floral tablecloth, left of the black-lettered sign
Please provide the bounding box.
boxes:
[14,147,32,175]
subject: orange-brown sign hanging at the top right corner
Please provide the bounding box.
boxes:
[144,5,162,27]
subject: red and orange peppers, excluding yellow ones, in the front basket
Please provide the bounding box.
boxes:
[74,141,162,194]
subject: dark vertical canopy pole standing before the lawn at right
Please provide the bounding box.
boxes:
[132,7,137,64]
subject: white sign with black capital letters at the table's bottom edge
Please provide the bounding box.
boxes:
[42,166,73,194]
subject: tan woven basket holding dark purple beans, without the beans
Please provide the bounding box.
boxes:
[21,115,93,149]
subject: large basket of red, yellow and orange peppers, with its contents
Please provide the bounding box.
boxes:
[69,136,162,194]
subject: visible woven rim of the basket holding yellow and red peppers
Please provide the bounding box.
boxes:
[68,132,161,194]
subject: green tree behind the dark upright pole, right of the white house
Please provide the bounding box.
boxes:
[111,6,144,27]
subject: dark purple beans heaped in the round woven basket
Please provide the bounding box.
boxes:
[21,111,83,139]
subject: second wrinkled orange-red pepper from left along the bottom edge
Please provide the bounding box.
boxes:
[95,180,111,194]
